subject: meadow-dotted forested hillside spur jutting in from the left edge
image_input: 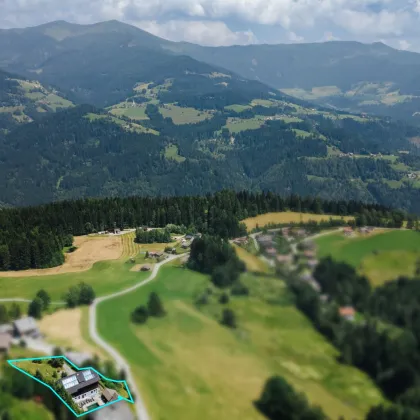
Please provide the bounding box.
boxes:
[0,70,72,131]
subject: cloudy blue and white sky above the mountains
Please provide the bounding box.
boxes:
[0,0,420,52]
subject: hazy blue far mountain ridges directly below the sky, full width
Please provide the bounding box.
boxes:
[0,21,420,124]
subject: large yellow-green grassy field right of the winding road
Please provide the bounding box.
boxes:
[98,266,381,420]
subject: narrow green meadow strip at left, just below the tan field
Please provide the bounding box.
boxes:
[0,260,148,301]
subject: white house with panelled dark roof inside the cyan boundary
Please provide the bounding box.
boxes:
[59,369,101,403]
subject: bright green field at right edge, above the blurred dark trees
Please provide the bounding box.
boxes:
[316,230,420,286]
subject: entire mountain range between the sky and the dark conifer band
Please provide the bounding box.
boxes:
[0,21,420,211]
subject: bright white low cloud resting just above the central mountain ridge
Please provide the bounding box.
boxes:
[136,20,257,46]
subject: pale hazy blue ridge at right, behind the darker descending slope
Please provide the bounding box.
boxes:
[178,41,420,124]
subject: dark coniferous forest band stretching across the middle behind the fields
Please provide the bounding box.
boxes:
[0,191,404,270]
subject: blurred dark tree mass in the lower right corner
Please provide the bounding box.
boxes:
[288,254,420,420]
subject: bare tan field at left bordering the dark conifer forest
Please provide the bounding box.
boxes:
[0,236,123,277]
